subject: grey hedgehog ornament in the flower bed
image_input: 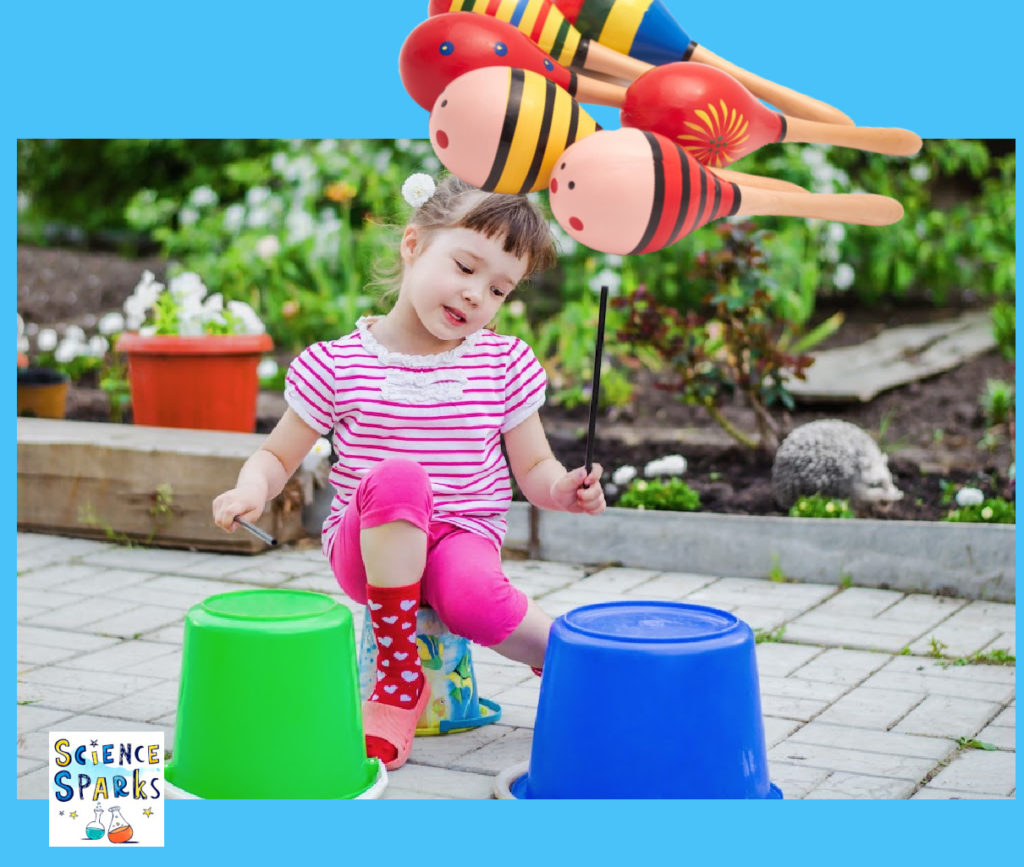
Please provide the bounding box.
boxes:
[771,419,903,509]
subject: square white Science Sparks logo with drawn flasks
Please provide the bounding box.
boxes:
[49,731,164,847]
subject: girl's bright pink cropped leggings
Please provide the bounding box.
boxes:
[331,459,527,647]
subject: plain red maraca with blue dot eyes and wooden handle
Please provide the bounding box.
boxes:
[398,12,625,112]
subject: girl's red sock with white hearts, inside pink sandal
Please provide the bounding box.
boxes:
[366,581,423,762]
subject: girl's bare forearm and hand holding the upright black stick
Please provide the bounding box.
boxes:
[505,413,604,515]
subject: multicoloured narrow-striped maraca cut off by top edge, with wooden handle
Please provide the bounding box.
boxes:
[427,0,650,81]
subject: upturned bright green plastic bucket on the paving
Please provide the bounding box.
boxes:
[166,590,381,798]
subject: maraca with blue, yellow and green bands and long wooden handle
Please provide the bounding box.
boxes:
[553,0,853,124]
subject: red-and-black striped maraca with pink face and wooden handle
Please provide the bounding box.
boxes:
[548,129,903,255]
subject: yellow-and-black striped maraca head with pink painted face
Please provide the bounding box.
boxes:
[430,67,598,192]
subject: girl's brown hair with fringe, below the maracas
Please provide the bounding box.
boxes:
[375,175,558,299]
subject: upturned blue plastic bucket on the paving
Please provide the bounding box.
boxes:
[509,601,782,798]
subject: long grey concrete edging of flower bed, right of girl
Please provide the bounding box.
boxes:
[505,503,1016,602]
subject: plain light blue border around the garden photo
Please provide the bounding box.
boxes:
[0,0,1021,867]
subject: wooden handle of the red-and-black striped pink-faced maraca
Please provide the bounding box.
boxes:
[733,184,903,226]
